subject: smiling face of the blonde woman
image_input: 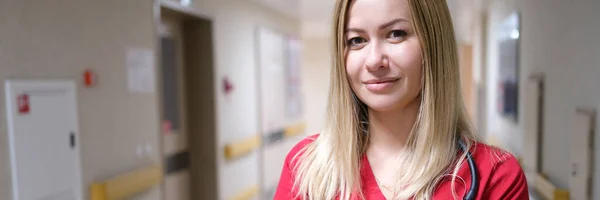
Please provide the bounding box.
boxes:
[345,0,423,111]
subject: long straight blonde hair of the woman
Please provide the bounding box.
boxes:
[293,0,478,200]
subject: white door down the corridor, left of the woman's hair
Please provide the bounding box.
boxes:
[258,28,290,199]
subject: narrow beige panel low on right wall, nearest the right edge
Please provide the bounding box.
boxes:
[569,110,594,200]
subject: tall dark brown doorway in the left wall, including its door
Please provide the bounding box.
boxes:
[158,5,217,200]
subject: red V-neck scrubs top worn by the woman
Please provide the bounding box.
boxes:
[275,135,529,200]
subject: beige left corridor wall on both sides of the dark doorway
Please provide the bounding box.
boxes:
[0,0,300,199]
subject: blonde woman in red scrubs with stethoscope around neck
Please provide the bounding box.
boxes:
[275,0,528,200]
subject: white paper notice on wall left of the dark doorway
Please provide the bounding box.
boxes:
[127,48,155,93]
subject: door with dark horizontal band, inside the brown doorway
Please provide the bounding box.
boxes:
[159,10,190,200]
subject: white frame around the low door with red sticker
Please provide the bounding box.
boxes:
[5,80,85,200]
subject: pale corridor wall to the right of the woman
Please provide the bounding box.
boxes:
[487,0,600,193]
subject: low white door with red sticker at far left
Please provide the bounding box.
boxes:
[5,81,83,200]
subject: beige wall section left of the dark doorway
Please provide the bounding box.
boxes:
[0,0,159,200]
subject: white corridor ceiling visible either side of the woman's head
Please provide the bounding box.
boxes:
[252,0,485,42]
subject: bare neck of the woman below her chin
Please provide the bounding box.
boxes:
[369,99,419,155]
